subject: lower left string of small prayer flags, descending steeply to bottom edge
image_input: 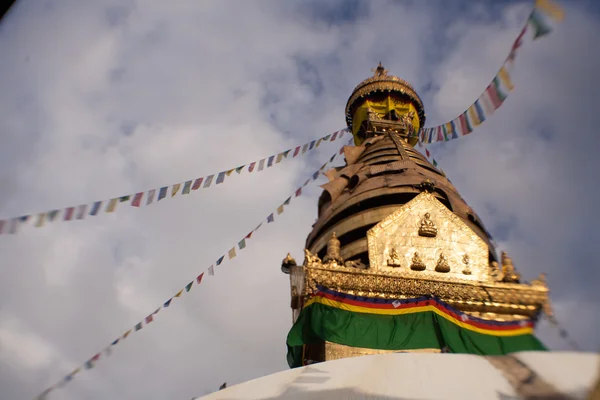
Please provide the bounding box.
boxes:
[38,143,346,399]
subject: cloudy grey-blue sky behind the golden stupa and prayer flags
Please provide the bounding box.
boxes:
[0,0,600,399]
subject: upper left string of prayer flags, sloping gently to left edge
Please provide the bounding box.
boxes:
[0,129,347,235]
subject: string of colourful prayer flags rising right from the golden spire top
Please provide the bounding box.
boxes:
[417,0,564,143]
